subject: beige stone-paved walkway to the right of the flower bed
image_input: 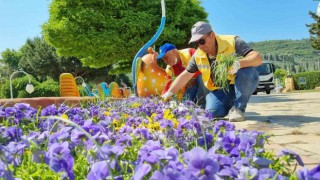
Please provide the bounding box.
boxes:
[235,92,320,169]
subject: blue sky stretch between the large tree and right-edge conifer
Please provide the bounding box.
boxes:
[203,0,319,42]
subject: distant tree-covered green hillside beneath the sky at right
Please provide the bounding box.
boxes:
[250,39,320,73]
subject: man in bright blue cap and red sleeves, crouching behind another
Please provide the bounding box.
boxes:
[157,43,204,106]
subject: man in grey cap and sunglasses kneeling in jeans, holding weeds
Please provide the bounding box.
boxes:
[162,21,262,122]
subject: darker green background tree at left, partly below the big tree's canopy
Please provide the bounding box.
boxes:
[19,37,121,82]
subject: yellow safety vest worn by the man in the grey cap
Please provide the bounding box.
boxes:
[195,35,235,91]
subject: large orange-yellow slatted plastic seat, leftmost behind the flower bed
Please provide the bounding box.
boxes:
[60,73,80,97]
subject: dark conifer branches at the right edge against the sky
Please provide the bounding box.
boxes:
[307,11,320,50]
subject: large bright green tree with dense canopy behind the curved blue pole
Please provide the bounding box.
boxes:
[42,0,207,73]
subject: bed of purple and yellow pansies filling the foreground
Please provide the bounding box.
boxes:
[0,98,320,180]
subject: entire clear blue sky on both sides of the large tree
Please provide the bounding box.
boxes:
[0,0,319,52]
